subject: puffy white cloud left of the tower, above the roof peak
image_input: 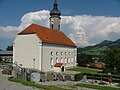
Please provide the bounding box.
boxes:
[21,10,49,27]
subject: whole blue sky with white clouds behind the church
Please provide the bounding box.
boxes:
[0,0,120,49]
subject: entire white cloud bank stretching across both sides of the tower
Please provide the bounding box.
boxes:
[0,10,120,46]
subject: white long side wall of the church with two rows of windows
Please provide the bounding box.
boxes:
[43,44,76,71]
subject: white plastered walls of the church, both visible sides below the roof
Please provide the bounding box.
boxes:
[13,34,77,71]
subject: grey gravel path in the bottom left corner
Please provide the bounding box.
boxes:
[0,70,42,90]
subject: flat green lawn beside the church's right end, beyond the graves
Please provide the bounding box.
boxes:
[68,67,101,74]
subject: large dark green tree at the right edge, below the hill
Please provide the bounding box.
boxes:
[105,48,120,74]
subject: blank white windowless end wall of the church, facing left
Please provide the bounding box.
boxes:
[13,34,41,70]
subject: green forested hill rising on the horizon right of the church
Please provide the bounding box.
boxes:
[78,39,120,55]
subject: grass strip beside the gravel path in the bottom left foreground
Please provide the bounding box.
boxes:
[9,79,67,90]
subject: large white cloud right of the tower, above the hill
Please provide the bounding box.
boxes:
[62,15,120,46]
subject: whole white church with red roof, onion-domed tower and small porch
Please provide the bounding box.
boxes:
[13,0,77,72]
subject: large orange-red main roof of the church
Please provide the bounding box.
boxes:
[18,24,76,47]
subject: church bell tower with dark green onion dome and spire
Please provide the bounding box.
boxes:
[50,0,61,31]
